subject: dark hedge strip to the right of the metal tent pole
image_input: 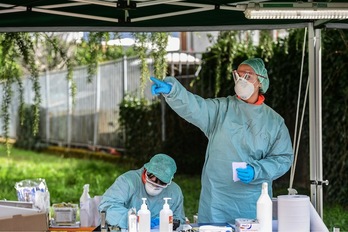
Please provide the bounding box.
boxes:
[322,30,348,205]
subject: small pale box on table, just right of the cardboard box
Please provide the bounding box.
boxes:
[52,203,78,225]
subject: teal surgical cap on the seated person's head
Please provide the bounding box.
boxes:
[144,154,176,183]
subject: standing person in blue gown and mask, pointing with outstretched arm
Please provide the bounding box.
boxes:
[151,58,293,224]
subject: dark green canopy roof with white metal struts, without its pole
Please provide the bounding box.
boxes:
[0,0,348,32]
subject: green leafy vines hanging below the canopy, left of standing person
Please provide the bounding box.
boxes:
[0,32,168,154]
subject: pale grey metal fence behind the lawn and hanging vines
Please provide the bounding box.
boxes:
[0,53,201,149]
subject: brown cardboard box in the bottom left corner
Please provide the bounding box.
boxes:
[0,213,49,232]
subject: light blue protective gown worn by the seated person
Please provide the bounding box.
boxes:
[99,168,185,229]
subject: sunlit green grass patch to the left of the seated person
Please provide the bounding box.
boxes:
[0,147,131,204]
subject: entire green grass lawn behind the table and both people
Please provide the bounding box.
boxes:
[0,146,348,232]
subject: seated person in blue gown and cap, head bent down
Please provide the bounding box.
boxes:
[99,154,185,229]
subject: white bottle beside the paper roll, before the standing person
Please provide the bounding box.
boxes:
[256,182,272,232]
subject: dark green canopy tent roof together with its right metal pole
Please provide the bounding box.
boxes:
[0,0,348,219]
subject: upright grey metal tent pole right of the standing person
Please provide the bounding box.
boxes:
[308,23,324,217]
